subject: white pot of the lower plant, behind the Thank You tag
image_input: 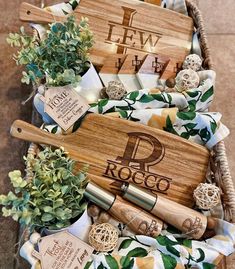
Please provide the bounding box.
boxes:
[44,210,92,242]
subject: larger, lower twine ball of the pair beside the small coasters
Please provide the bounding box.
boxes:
[175,69,200,92]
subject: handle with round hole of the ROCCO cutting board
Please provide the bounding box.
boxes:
[10,120,64,148]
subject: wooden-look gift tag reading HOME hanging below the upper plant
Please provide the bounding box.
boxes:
[44,86,89,131]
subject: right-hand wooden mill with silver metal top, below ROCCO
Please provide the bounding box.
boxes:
[122,183,209,239]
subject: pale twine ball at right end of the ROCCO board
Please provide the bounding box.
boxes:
[193,183,220,210]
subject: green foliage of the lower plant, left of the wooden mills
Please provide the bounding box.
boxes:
[0,148,87,229]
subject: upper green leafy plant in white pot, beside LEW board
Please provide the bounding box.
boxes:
[7,16,102,123]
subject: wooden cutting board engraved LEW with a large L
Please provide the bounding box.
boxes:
[20,0,193,65]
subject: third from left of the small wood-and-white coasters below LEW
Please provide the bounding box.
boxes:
[136,54,169,89]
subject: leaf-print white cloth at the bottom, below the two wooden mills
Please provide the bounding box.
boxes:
[83,220,235,269]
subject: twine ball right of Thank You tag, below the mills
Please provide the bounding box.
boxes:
[89,223,118,252]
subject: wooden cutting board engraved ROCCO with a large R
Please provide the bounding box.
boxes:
[11,114,209,206]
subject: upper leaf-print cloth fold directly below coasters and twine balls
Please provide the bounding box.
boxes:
[90,70,215,113]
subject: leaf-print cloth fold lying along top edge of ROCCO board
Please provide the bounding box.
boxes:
[106,108,229,149]
